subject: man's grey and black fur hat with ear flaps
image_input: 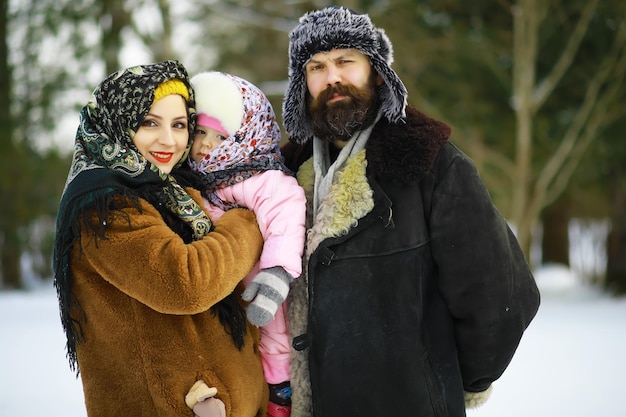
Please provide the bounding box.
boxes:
[283,6,407,144]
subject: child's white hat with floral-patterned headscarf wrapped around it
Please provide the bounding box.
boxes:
[189,72,291,210]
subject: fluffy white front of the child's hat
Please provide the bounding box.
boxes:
[191,71,244,135]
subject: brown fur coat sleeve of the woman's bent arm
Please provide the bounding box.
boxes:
[82,188,262,314]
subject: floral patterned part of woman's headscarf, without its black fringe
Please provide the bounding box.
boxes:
[66,61,211,239]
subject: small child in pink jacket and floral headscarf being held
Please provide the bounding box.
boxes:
[184,72,306,417]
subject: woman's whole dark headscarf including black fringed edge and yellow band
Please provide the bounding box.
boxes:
[53,61,212,369]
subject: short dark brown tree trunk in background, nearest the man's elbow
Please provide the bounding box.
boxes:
[541,198,571,266]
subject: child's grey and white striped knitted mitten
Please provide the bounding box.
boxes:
[242,266,293,326]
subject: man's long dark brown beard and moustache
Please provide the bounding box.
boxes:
[308,77,380,142]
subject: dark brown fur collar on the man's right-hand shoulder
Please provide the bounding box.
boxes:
[366,107,451,184]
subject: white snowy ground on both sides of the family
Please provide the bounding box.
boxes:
[0,266,626,417]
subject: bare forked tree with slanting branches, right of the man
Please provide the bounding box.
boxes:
[511,0,626,254]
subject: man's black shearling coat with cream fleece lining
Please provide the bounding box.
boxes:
[284,108,539,417]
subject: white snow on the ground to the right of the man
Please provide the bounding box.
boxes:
[468,266,626,417]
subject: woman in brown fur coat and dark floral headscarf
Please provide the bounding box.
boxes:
[54,61,268,417]
